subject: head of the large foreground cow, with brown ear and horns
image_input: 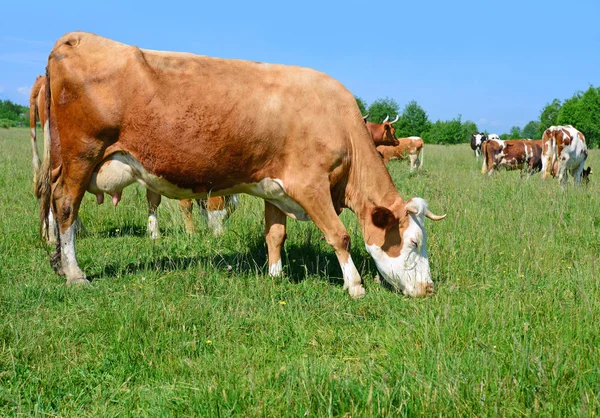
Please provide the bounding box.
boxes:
[365,198,446,296]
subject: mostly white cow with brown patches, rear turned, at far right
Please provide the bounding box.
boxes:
[542,125,588,184]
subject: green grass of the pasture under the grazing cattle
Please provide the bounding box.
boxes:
[0,129,600,417]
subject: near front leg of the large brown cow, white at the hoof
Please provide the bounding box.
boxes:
[290,179,365,298]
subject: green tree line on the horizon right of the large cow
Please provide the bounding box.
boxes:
[356,86,600,148]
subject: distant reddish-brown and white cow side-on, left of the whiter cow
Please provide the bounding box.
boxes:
[481,139,542,176]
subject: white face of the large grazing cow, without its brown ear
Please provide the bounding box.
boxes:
[366,198,443,296]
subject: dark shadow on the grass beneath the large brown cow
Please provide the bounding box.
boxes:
[88,233,373,285]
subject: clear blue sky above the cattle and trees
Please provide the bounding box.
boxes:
[0,0,600,133]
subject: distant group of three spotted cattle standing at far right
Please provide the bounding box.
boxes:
[471,129,592,184]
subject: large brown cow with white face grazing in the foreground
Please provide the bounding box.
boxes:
[38,32,443,297]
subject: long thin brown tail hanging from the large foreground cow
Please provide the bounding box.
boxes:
[35,67,52,240]
